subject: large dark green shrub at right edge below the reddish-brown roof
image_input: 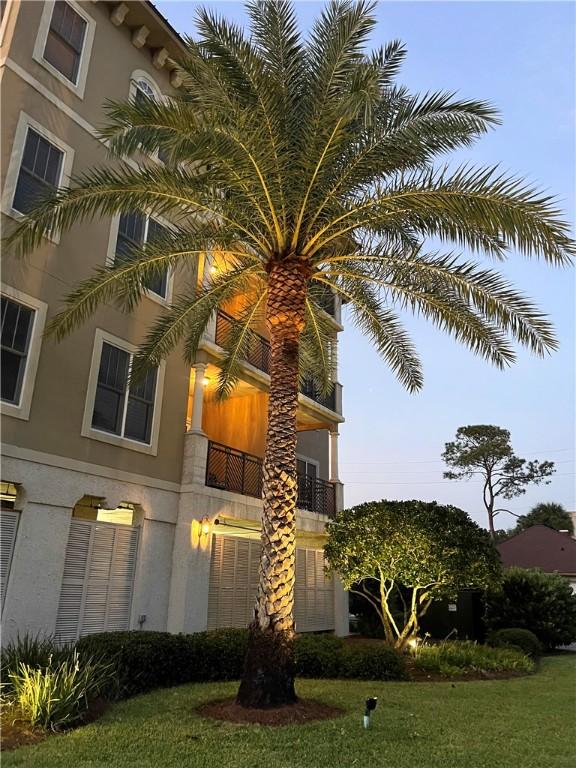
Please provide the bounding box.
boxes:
[486,568,576,648]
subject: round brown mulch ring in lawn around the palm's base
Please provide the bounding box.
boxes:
[198,699,344,726]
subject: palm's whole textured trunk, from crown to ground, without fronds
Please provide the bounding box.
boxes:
[236,260,308,707]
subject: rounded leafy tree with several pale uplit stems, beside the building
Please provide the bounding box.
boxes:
[324,500,500,649]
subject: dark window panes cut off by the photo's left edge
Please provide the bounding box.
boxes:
[0,296,34,405]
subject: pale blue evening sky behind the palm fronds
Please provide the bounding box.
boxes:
[156,0,576,527]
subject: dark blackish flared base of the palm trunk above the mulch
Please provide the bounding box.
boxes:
[236,623,298,709]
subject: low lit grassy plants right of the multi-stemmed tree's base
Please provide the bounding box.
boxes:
[414,641,534,677]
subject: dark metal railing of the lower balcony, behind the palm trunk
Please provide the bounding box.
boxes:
[206,442,336,517]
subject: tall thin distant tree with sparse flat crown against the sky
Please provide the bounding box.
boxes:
[442,424,556,541]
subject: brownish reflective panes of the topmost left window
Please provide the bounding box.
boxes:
[44,0,88,85]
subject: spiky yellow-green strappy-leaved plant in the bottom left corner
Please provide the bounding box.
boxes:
[7,651,112,730]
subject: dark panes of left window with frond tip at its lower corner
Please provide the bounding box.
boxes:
[12,126,64,213]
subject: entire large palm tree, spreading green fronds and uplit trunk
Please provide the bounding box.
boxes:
[6,0,574,706]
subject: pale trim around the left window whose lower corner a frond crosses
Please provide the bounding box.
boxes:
[1,112,74,237]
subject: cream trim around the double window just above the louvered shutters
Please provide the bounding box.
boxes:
[80,328,166,456]
